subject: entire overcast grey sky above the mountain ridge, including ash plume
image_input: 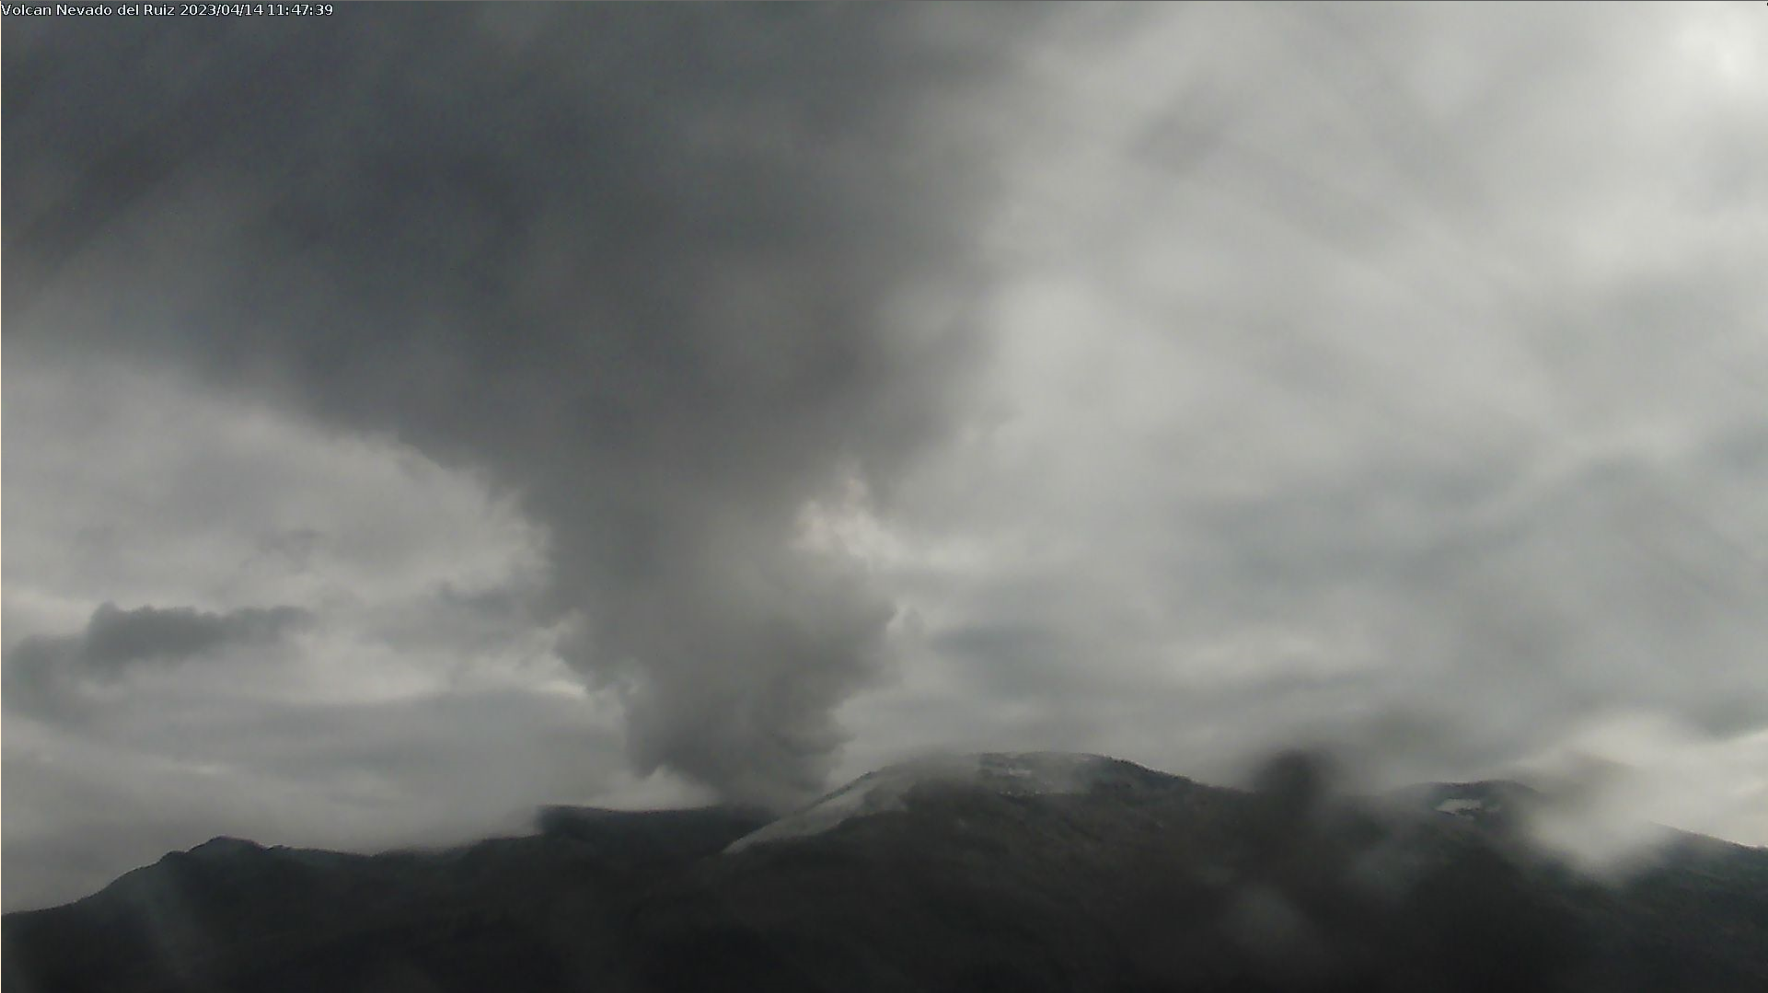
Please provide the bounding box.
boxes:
[0,2,1768,910]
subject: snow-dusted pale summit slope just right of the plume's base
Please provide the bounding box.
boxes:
[727,751,1119,852]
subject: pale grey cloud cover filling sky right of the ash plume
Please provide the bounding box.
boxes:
[823,5,1768,826]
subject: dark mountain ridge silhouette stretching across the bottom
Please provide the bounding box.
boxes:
[4,754,1768,993]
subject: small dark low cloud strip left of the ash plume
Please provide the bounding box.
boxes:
[5,603,311,716]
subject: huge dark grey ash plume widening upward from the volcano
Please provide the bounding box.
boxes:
[4,5,1029,800]
